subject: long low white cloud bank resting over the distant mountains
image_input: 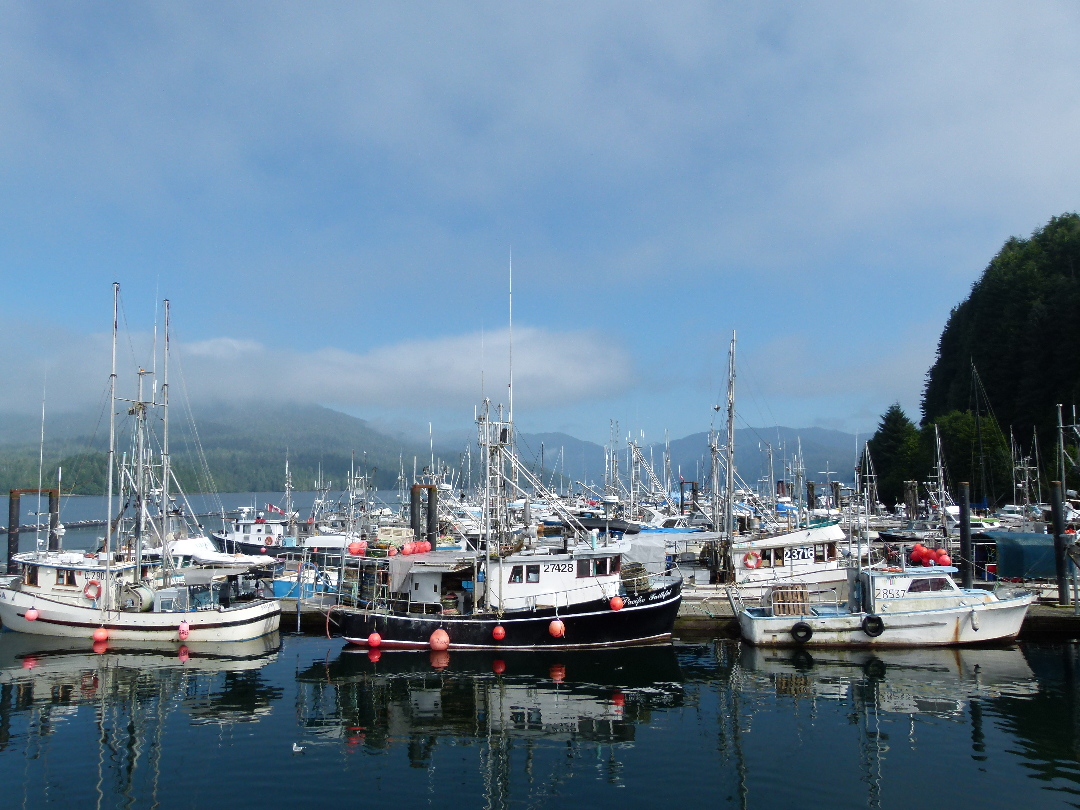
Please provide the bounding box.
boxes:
[0,324,635,418]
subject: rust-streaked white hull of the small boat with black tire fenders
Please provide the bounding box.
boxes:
[739,594,1035,647]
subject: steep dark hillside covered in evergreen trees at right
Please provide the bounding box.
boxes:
[870,214,1080,507]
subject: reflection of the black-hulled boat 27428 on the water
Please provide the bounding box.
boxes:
[299,645,684,767]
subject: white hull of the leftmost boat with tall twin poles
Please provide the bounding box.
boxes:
[0,589,281,643]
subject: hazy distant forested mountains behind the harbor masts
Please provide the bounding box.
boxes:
[0,405,855,494]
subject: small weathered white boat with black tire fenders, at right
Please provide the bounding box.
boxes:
[728,565,1035,647]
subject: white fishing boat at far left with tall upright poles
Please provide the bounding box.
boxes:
[0,284,281,643]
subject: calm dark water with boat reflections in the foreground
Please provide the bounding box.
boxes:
[0,633,1080,810]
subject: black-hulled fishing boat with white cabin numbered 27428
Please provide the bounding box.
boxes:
[330,400,681,650]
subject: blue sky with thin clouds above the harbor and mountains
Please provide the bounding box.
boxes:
[0,0,1080,442]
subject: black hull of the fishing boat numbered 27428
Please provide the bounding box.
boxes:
[332,580,683,650]
